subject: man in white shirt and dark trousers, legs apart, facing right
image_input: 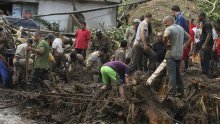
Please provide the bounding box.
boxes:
[130,13,156,73]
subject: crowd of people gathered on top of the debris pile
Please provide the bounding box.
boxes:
[0,5,220,97]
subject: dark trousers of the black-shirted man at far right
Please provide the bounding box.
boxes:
[200,49,212,75]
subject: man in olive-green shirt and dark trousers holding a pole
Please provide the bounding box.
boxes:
[27,32,50,89]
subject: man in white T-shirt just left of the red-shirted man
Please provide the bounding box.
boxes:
[52,34,64,68]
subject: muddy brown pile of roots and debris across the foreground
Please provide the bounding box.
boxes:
[1,66,220,124]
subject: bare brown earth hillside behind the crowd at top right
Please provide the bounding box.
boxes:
[128,0,200,31]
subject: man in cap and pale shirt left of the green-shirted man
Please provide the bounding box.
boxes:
[13,39,33,82]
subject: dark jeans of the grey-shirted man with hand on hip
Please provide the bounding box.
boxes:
[166,58,184,96]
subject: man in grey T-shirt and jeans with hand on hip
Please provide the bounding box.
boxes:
[163,16,190,97]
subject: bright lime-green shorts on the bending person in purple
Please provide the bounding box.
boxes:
[101,66,123,85]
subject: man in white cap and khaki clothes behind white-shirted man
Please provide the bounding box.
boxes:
[124,19,141,58]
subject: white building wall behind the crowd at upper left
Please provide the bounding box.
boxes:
[3,0,117,32]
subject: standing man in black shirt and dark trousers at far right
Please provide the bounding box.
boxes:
[198,12,214,76]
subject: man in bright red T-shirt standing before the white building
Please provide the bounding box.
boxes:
[75,22,90,58]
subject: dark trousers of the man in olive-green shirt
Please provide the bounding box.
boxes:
[32,68,49,89]
